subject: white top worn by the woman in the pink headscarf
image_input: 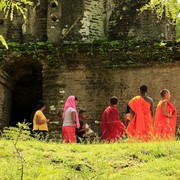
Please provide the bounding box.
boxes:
[63,107,76,126]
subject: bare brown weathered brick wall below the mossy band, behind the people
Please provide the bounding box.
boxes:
[0,53,180,136]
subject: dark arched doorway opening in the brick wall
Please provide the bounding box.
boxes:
[5,59,43,126]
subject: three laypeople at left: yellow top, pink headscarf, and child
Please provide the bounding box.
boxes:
[32,96,94,143]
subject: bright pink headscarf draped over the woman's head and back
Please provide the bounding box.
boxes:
[62,96,80,128]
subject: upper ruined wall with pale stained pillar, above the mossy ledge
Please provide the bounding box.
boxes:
[0,0,176,44]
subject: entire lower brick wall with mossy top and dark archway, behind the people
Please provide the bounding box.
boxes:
[0,41,180,137]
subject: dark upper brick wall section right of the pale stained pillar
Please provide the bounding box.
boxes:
[109,0,176,40]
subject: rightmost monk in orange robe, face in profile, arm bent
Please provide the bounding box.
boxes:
[153,89,177,140]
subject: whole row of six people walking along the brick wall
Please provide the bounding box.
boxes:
[33,85,177,143]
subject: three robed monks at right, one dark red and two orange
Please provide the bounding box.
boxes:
[101,85,177,142]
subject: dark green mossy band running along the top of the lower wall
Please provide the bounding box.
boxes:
[0,41,180,68]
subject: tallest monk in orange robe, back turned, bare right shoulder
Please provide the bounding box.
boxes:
[126,85,153,141]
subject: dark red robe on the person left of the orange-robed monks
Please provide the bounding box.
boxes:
[100,105,125,142]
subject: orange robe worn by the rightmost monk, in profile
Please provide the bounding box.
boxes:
[153,100,177,140]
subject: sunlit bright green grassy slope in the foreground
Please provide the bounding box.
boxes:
[0,139,180,180]
